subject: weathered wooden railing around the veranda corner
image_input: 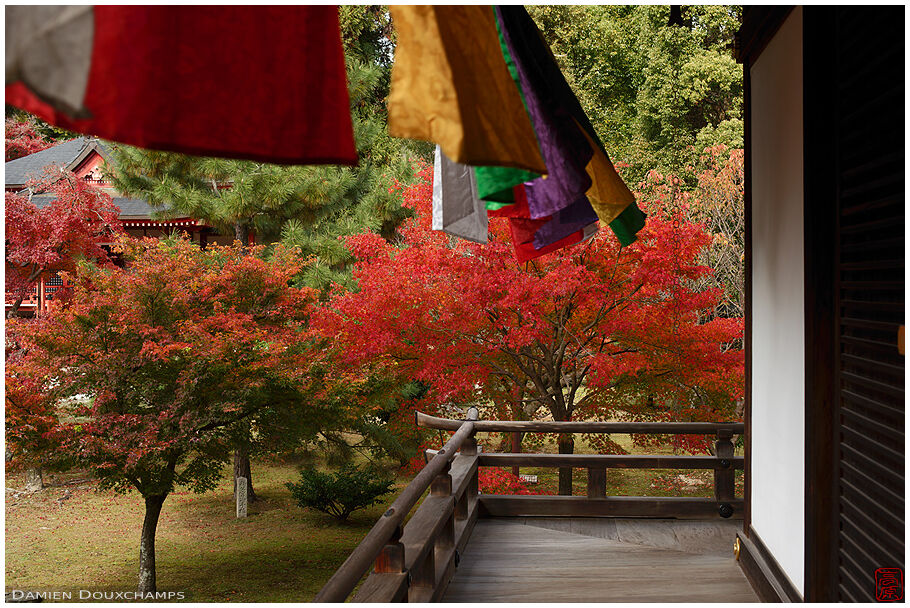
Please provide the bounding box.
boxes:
[315,408,744,602]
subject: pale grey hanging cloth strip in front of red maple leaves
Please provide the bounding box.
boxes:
[433,146,488,243]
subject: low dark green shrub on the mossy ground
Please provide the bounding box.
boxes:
[285,464,392,521]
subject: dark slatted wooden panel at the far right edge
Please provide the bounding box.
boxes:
[832,7,905,601]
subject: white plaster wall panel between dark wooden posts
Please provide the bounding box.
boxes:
[751,7,805,590]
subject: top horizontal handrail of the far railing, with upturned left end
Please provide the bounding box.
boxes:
[415,412,745,435]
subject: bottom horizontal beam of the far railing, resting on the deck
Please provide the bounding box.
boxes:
[480,494,743,519]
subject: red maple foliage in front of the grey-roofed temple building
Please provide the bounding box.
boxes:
[6,167,123,316]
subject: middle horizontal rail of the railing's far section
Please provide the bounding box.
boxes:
[478,452,745,470]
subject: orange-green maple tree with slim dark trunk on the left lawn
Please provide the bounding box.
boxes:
[7,239,321,593]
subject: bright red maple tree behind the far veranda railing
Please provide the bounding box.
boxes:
[318,169,743,493]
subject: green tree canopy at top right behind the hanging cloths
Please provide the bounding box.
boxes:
[529,6,743,185]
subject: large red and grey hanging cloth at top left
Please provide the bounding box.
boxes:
[6,5,357,165]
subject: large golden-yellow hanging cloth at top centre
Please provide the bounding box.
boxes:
[388,5,547,174]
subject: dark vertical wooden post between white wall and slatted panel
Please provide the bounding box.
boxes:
[803,6,841,602]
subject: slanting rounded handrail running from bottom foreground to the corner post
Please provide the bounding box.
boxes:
[313,420,477,602]
